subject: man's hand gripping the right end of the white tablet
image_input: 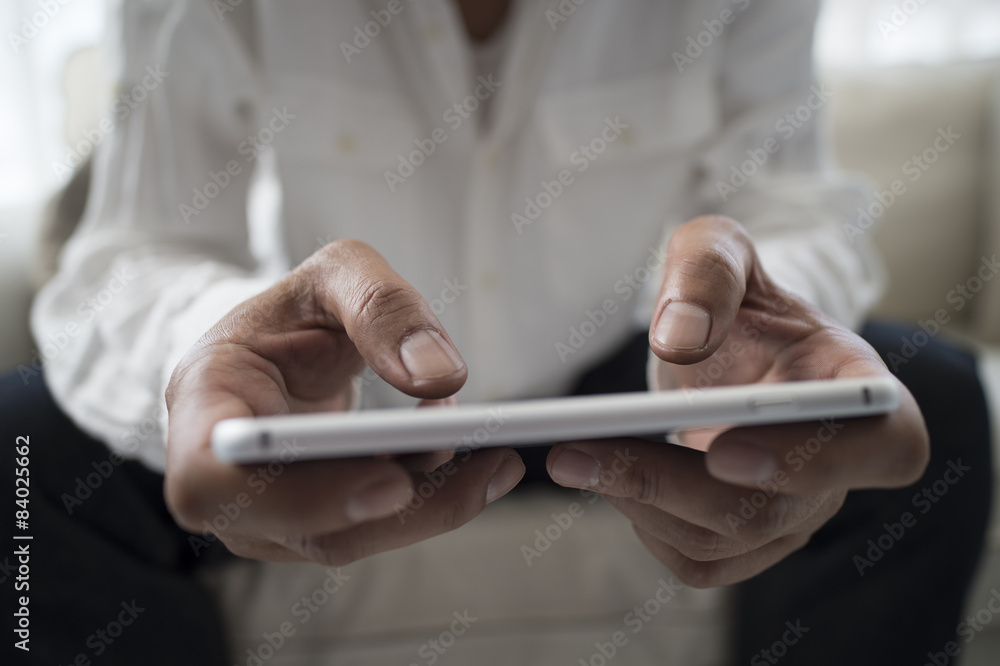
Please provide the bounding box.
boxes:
[547,217,930,587]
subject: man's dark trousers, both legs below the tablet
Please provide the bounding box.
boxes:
[0,325,992,666]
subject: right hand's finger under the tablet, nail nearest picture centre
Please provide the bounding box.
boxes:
[546,439,809,544]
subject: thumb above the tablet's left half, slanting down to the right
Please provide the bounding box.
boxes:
[303,240,467,398]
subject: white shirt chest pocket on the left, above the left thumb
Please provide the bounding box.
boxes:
[262,77,437,264]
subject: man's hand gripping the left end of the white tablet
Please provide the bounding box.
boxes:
[165,241,524,565]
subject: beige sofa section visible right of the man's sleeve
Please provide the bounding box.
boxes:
[826,61,1000,666]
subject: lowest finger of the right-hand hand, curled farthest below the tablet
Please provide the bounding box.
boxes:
[635,527,809,588]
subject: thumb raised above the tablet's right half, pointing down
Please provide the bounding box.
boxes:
[649,216,763,364]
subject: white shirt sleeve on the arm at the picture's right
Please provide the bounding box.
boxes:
[647,0,884,390]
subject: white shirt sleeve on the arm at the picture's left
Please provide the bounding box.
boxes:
[31,1,276,469]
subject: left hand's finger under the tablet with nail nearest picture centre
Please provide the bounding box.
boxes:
[270,448,524,566]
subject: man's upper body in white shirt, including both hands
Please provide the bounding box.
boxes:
[19,0,982,663]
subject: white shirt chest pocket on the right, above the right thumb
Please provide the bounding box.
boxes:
[532,71,721,318]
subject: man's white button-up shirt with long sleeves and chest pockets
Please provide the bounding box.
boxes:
[32,0,878,469]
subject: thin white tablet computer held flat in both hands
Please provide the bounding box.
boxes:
[212,377,899,463]
